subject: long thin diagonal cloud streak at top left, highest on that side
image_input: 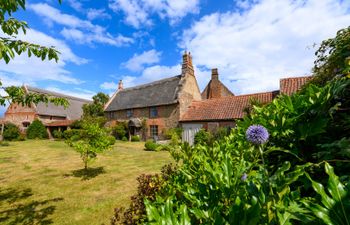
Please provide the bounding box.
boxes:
[29,3,133,47]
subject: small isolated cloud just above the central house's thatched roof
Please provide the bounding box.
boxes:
[122,49,162,71]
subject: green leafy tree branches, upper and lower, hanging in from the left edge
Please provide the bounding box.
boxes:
[0,0,68,107]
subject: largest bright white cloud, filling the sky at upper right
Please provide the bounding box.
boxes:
[180,0,350,94]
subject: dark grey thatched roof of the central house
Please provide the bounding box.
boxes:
[105,75,181,111]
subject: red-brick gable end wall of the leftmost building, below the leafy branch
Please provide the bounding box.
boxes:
[5,104,37,132]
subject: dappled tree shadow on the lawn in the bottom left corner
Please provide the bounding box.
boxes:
[0,188,63,225]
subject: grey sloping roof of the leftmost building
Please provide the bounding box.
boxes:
[25,86,91,120]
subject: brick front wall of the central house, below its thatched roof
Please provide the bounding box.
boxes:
[106,104,179,138]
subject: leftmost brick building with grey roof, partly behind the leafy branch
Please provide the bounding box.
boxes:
[4,85,90,135]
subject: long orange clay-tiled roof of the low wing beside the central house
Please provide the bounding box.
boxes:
[180,91,278,122]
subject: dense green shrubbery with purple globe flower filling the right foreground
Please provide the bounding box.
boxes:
[112,28,350,225]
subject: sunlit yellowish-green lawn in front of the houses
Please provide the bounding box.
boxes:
[0,141,171,225]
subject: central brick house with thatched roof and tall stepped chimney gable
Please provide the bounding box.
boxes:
[105,52,202,139]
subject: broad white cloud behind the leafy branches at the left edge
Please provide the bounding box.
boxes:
[0,29,88,84]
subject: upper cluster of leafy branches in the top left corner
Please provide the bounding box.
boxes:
[0,0,61,63]
